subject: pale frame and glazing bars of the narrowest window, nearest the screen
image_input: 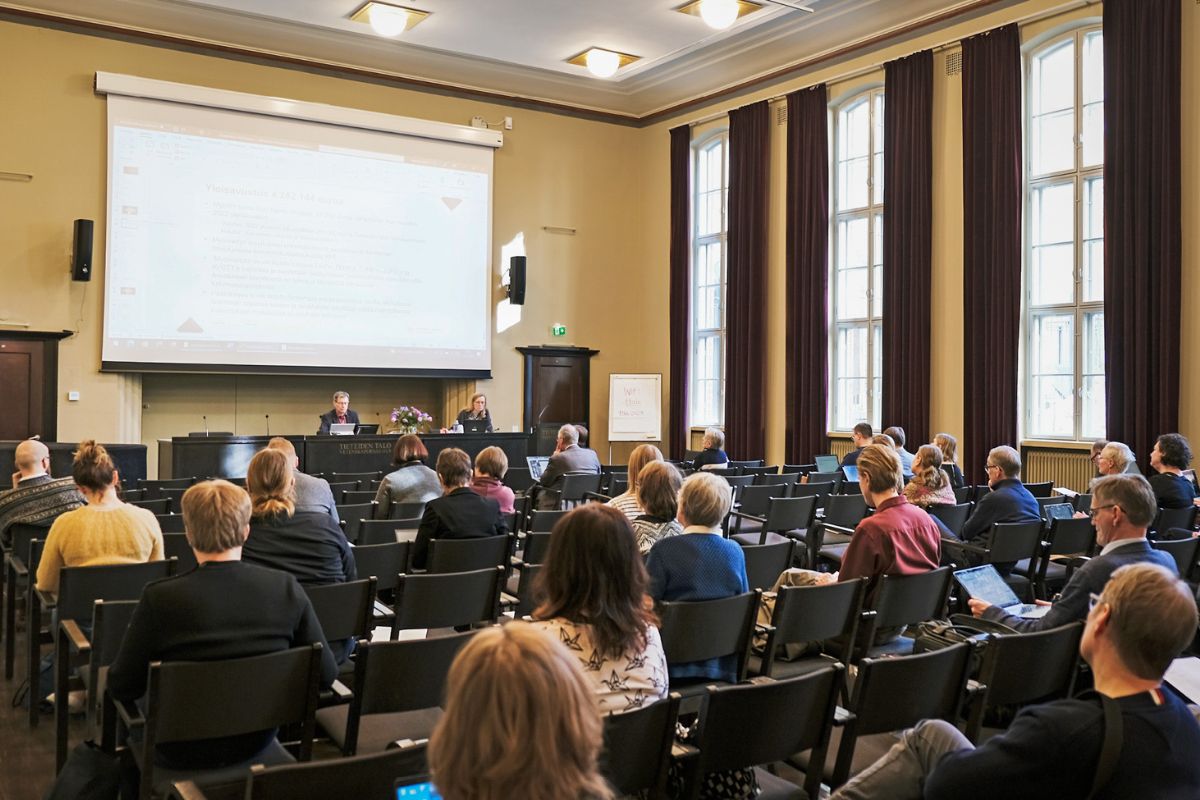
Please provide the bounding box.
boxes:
[688,127,730,428]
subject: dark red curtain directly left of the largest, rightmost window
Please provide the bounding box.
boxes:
[955,25,1022,483]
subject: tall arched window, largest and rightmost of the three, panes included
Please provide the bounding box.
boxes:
[1025,28,1105,440]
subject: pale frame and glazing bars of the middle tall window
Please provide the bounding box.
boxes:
[826,82,886,434]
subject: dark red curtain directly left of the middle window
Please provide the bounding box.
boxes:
[784,84,829,464]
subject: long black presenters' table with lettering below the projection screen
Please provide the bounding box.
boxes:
[158,433,529,479]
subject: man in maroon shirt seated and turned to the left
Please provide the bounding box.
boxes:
[838,445,942,644]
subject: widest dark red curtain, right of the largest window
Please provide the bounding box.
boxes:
[1104,0,1181,470]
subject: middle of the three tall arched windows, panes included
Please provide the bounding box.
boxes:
[829,88,883,431]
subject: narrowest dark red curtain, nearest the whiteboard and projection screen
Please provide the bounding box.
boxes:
[667,125,691,458]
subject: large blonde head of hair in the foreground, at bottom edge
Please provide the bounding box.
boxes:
[428,621,612,800]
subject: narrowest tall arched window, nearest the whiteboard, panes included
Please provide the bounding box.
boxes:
[689,131,730,426]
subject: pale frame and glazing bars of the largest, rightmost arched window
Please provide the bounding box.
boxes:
[1020,20,1106,443]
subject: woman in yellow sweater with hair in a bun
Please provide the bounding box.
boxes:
[37,439,163,597]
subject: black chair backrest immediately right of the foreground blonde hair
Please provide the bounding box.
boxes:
[600,694,679,798]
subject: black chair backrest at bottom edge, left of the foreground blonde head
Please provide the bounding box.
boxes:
[246,742,428,800]
